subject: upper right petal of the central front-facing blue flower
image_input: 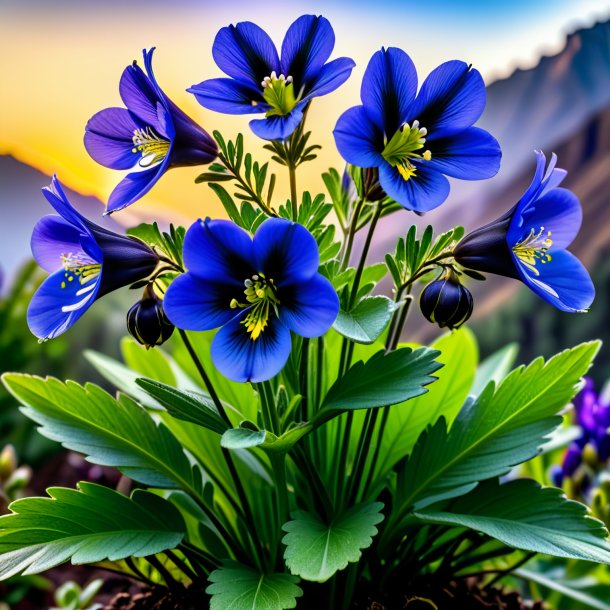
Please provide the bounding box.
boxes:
[254,218,320,287]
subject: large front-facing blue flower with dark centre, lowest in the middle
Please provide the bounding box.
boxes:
[163,218,339,382]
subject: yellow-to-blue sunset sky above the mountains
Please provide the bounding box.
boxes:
[0,0,610,221]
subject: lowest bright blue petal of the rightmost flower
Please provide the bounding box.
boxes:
[514,250,595,312]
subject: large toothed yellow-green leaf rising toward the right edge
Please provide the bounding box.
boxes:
[397,342,599,510]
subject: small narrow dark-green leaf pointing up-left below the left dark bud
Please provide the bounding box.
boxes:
[136,378,228,434]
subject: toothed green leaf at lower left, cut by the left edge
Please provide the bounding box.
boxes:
[0,482,185,579]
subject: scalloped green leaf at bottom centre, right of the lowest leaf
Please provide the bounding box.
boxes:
[282,502,383,582]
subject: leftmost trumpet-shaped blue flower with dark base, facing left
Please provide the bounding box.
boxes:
[27,177,159,340]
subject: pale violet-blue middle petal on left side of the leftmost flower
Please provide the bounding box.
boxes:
[30,216,88,272]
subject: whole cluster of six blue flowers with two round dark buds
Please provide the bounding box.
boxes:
[28,15,594,382]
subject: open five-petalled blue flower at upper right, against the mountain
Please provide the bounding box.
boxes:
[334,47,502,212]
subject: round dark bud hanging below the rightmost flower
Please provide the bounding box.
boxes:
[419,271,474,330]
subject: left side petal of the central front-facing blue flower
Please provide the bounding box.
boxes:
[163,273,238,330]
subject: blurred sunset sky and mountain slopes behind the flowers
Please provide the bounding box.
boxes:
[0,0,610,381]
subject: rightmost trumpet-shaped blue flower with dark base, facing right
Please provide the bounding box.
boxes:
[454,152,595,312]
